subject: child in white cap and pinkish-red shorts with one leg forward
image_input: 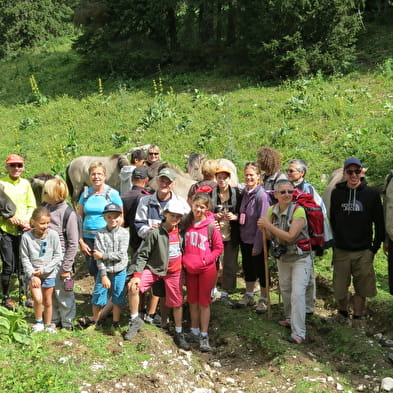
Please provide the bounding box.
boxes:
[124,200,190,350]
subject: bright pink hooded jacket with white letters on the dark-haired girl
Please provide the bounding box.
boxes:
[183,212,224,274]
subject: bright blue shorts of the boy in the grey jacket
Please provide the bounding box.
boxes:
[91,269,126,307]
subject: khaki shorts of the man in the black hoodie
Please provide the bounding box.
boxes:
[333,248,377,300]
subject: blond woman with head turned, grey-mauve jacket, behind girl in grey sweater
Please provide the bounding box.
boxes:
[43,178,79,330]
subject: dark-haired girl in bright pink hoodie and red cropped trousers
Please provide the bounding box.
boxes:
[183,192,224,352]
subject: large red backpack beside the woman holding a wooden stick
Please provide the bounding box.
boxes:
[292,189,325,255]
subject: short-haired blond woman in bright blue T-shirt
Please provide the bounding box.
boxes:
[77,162,123,277]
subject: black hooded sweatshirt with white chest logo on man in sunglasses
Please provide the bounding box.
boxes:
[330,180,385,253]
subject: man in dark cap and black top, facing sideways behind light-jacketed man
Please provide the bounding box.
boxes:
[122,167,149,254]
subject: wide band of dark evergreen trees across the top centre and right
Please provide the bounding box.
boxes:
[75,0,363,78]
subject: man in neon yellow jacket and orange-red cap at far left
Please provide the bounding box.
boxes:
[0,154,36,309]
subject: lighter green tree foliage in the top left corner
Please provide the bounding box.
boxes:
[0,0,72,58]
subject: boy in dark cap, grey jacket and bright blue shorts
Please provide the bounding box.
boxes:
[91,203,130,336]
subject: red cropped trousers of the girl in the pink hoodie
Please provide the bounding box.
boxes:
[186,263,217,307]
